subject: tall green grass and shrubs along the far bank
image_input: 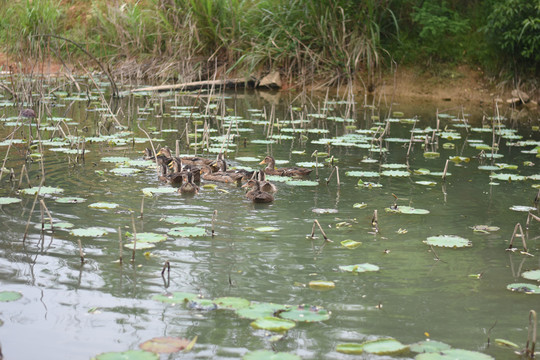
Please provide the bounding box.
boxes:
[0,0,540,86]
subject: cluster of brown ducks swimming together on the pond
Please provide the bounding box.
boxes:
[144,147,312,203]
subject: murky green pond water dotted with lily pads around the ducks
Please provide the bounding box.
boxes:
[0,81,540,359]
